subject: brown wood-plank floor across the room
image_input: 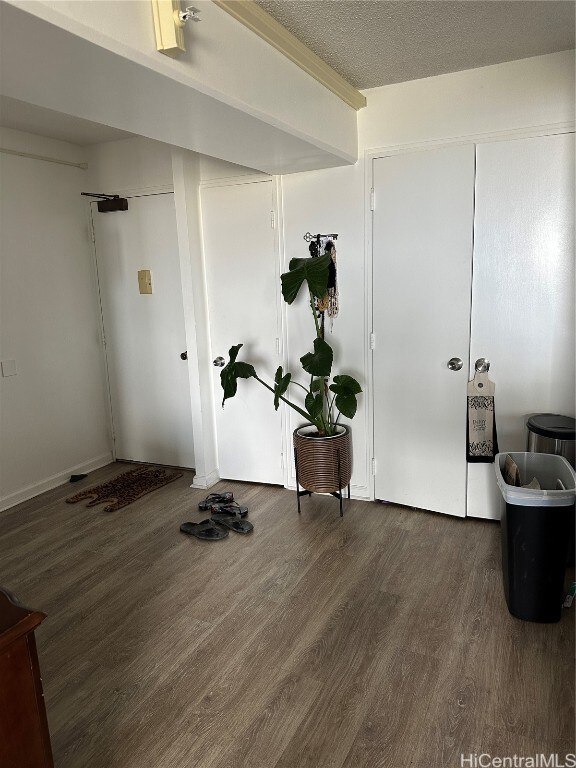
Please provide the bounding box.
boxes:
[0,464,574,768]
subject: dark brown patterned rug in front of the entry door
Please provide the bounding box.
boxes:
[66,467,184,512]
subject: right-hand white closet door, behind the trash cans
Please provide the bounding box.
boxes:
[468,134,575,518]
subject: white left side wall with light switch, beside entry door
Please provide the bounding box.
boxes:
[0,130,111,508]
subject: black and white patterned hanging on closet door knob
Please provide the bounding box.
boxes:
[466,357,498,464]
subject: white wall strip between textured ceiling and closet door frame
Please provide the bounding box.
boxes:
[358,51,574,151]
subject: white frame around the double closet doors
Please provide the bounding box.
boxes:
[361,121,576,501]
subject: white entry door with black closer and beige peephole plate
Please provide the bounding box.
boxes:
[91,193,194,467]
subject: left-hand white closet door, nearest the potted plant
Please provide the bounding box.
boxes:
[373,144,474,517]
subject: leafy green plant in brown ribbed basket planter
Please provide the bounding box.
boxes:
[220,237,362,508]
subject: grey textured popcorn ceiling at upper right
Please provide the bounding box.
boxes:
[256,0,575,89]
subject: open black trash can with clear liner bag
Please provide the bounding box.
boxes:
[495,452,576,622]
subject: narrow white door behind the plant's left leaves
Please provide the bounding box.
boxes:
[201,181,283,484]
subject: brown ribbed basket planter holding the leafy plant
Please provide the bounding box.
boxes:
[294,425,352,493]
